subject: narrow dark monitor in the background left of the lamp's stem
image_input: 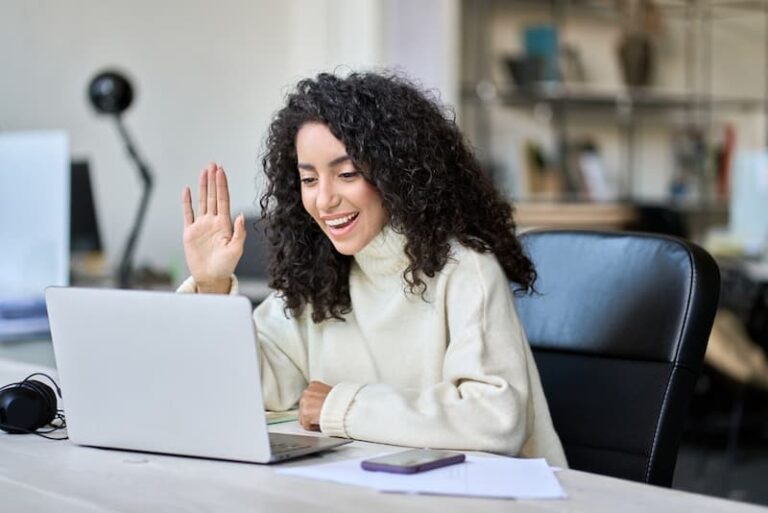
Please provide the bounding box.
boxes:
[69,160,102,253]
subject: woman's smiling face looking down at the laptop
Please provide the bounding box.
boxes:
[296,123,387,255]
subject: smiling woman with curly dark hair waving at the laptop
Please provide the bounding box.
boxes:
[180,73,566,465]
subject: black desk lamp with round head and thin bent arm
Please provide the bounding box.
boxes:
[88,71,152,289]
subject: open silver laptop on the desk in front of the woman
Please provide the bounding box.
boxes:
[45,287,350,463]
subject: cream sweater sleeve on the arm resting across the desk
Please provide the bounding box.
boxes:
[320,251,533,455]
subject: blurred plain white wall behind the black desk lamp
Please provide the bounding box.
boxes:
[0,0,458,280]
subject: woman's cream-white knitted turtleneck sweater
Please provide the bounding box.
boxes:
[179,228,566,466]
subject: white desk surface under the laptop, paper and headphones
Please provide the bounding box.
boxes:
[0,360,768,513]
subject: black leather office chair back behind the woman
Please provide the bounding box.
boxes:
[517,231,720,486]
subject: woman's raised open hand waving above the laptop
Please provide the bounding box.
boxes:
[181,162,245,294]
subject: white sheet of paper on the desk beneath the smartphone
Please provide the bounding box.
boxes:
[276,456,566,499]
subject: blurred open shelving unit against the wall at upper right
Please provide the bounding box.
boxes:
[461,0,768,233]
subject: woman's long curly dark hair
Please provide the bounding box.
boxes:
[260,73,536,322]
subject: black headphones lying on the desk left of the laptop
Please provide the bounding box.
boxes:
[0,372,65,438]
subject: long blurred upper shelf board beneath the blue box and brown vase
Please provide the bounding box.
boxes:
[462,83,768,114]
